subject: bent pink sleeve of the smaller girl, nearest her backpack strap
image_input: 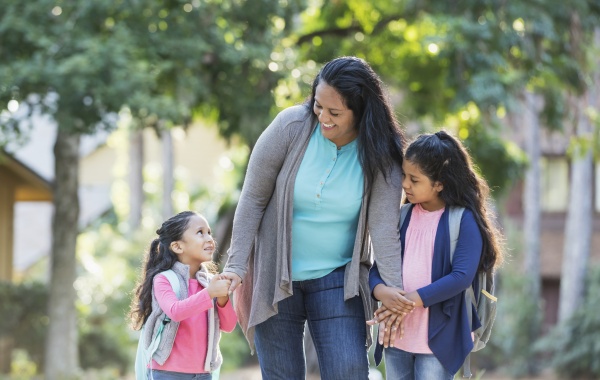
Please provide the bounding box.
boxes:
[153,275,213,322]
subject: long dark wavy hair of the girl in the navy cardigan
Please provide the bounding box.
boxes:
[404,131,503,273]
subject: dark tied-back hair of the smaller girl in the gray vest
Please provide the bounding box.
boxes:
[129,211,214,330]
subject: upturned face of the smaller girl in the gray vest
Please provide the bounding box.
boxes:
[171,215,215,274]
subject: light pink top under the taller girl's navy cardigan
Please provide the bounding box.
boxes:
[394,204,444,354]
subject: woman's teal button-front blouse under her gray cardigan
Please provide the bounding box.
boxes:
[292,125,364,281]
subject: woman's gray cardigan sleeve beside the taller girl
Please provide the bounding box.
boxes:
[368,165,402,288]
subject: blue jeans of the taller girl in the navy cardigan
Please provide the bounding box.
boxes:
[383,347,454,380]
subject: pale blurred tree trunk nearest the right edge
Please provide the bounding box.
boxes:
[558,28,600,322]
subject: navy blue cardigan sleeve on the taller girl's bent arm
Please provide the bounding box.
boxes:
[417,210,483,307]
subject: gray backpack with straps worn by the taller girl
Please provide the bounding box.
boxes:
[400,203,498,377]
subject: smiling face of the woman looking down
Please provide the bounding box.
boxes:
[313,81,358,148]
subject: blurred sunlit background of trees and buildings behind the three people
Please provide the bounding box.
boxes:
[0,0,600,380]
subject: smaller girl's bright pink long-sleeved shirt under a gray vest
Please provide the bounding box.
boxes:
[152,275,237,373]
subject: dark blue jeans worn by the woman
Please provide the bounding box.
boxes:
[254,267,369,380]
